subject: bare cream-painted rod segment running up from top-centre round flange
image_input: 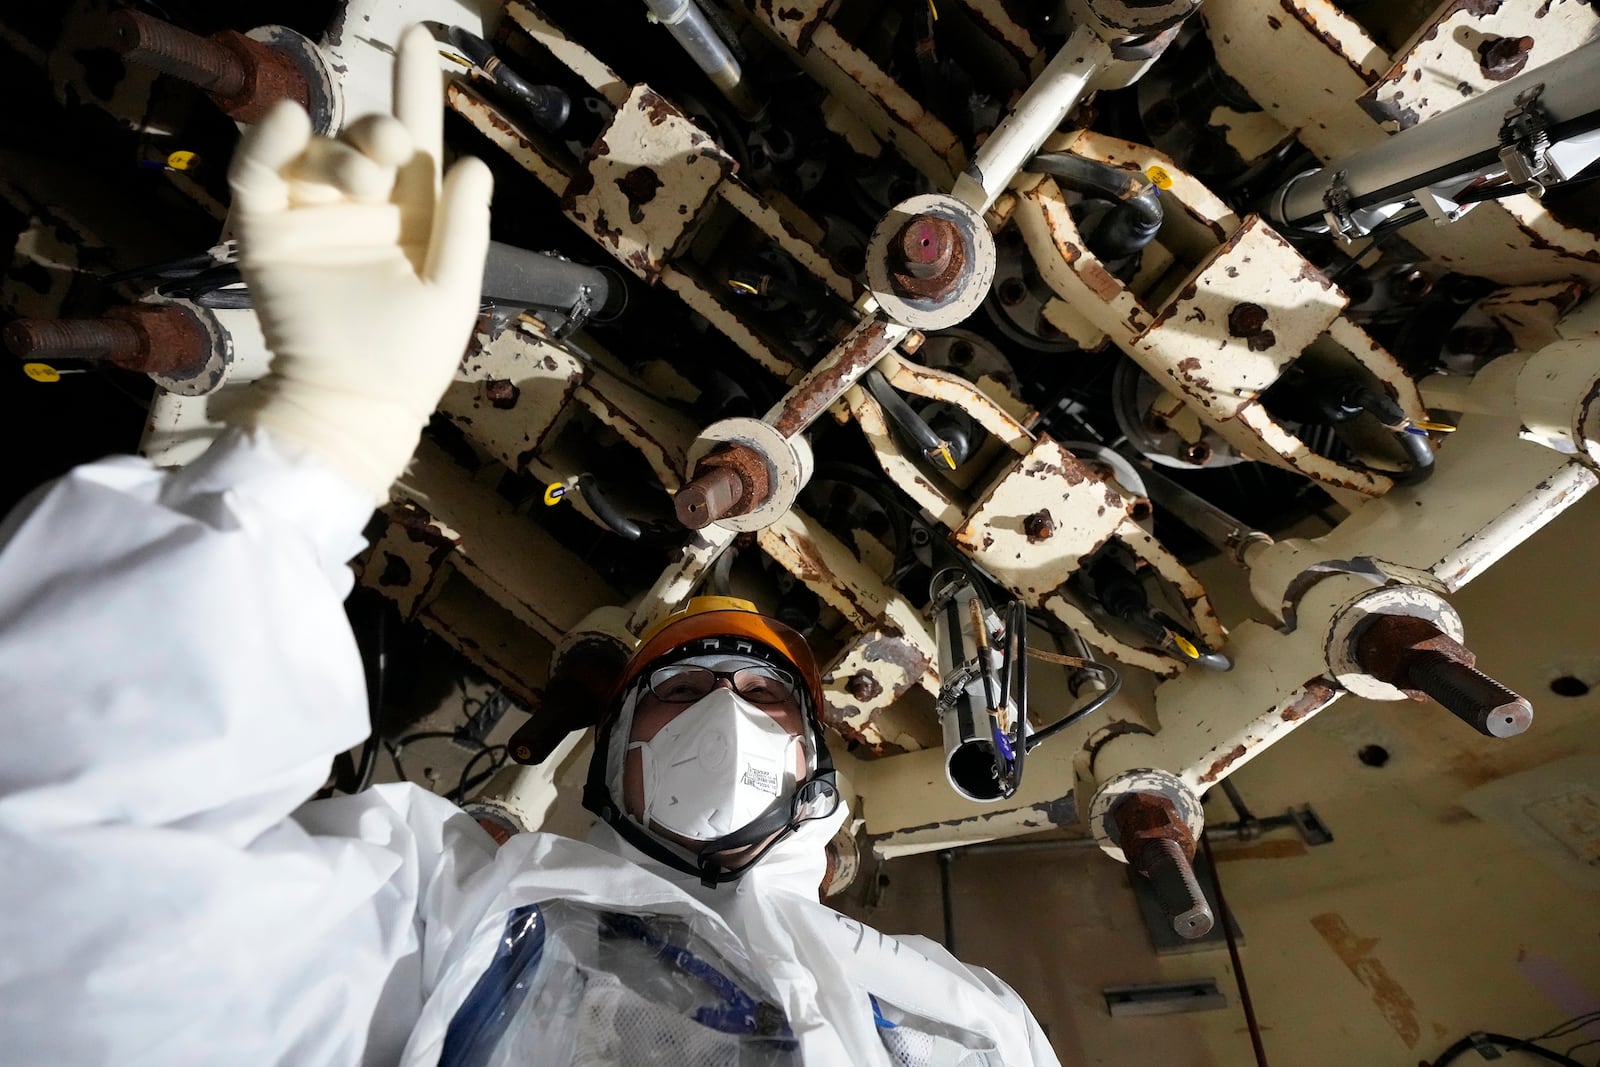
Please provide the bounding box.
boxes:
[950,26,1110,211]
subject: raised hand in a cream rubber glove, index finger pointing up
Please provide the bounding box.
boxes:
[229,26,493,501]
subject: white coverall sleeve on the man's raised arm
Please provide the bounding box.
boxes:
[0,432,493,1065]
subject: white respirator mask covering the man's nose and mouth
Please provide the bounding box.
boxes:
[627,686,802,841]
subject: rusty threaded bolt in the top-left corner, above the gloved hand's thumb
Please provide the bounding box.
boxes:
[109,11,310,122]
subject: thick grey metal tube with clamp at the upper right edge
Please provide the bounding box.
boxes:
[1272,42,1600,227]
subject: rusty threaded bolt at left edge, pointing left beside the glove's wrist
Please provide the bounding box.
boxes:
[5,304,211,376]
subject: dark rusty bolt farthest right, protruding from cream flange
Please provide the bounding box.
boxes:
[1352,614,1533,737]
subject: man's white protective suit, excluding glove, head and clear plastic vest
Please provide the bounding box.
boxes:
[0,430,1075,1067]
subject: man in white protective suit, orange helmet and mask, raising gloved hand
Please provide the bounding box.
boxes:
[0,29,1056,1067]
